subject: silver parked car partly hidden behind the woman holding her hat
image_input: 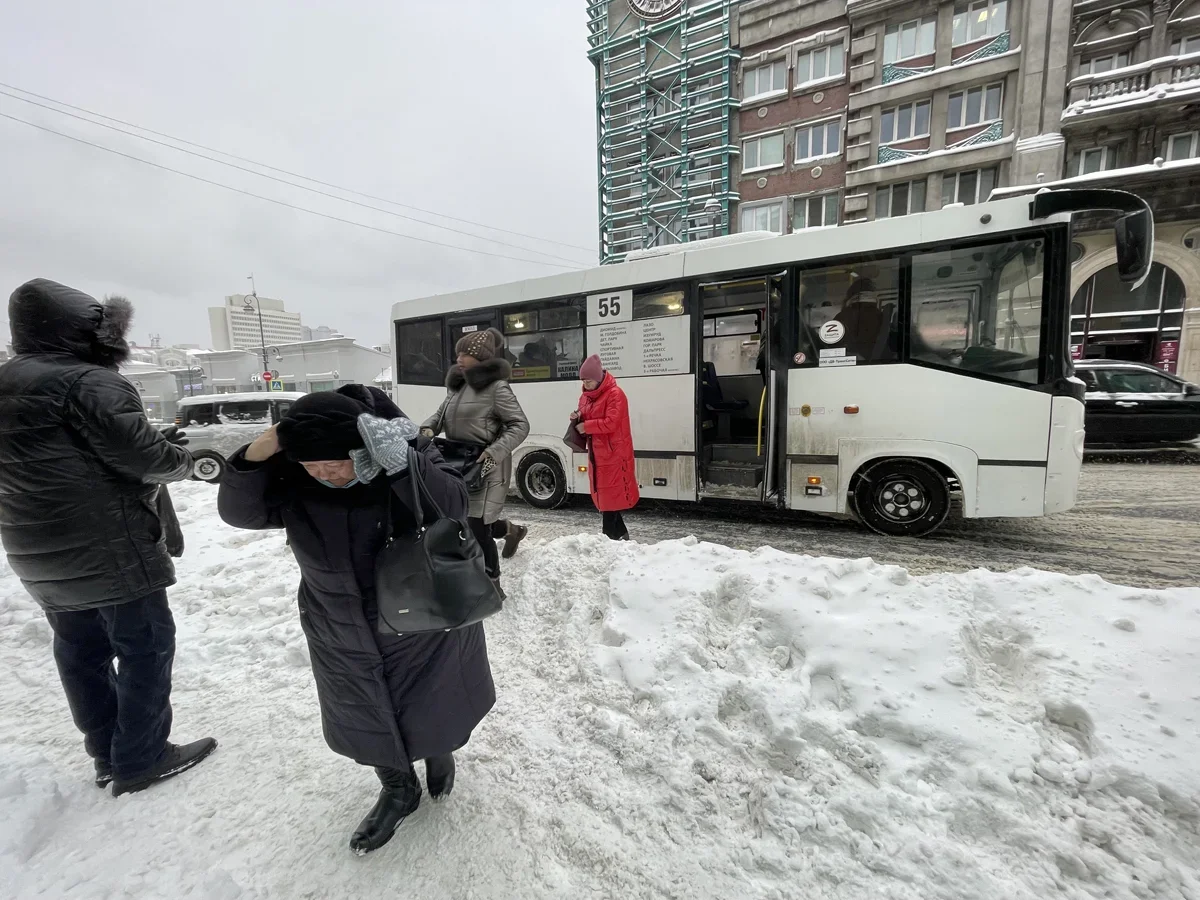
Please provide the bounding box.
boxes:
[175,391,304,485]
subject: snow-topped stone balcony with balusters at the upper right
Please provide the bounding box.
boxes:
[1062,53,1200,125]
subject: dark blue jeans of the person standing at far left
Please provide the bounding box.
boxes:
[46,590,175,778]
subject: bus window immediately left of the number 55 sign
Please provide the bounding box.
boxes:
[500,298,587,382]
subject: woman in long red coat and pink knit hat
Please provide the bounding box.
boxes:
[571,355,640,541]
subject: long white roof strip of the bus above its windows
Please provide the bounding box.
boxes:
[391,198,1070,320]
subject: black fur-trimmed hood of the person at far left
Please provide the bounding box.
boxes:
[8,278,133,368]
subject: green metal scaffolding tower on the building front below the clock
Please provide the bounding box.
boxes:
[587,0,740,263]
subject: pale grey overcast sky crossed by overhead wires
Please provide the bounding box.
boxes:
[0,0,596,346]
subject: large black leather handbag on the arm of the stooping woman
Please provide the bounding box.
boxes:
[376,449,504,635]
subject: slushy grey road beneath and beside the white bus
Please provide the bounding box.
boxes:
[510,455,1200,587]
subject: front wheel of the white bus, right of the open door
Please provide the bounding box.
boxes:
[853,460,950,538]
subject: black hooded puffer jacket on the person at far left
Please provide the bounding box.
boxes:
[0,278,192,611]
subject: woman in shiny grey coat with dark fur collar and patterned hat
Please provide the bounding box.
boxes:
[421,328,529,595]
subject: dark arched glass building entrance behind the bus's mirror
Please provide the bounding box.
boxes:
[1070,263,1187,372]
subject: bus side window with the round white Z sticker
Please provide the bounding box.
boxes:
[799,259,900,366]
